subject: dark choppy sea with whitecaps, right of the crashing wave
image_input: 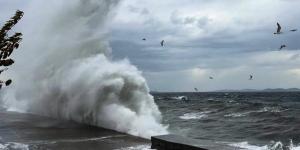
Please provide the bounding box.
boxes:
[153,92,300,149]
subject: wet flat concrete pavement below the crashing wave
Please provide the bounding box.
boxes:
[0,111,150,150]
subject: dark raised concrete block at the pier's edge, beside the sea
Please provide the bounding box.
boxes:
[151,134,234,150]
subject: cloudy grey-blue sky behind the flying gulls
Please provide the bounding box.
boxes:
[0,0,300,91]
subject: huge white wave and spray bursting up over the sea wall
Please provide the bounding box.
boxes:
[3,0,167,138]
